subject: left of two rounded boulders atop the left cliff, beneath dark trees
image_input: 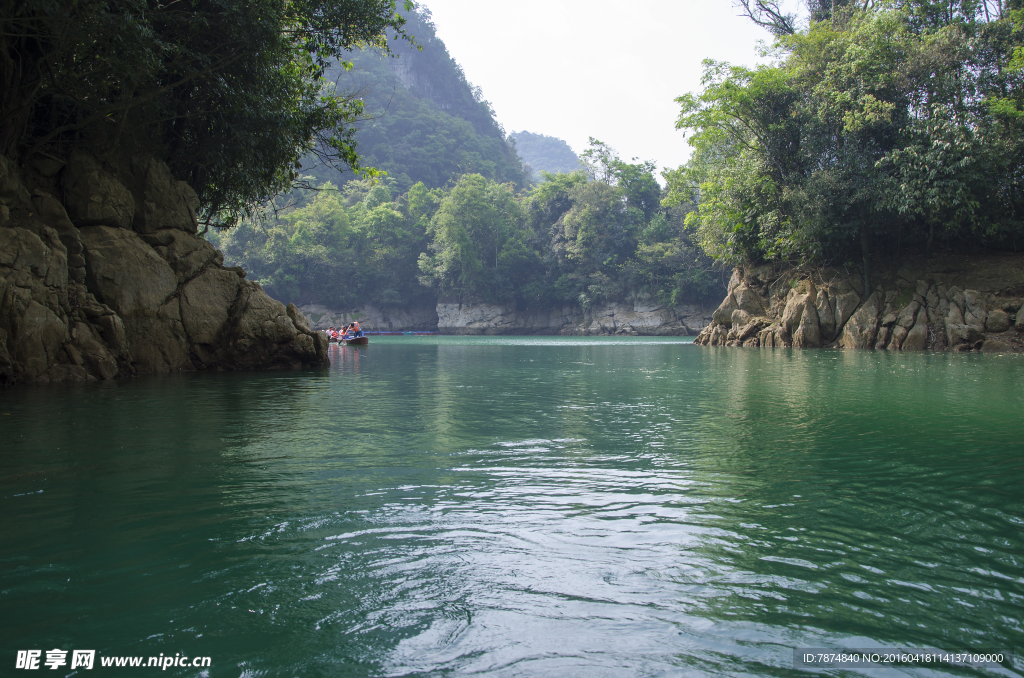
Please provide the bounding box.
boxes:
[65,153,135,228]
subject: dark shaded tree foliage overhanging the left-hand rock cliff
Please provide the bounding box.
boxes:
[0,0,404,223]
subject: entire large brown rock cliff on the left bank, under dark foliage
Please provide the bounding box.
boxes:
[0,153,328,384]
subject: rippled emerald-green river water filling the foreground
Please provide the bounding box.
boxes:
[0,337,1024,677]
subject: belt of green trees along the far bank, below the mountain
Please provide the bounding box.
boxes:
[209,141,724,308]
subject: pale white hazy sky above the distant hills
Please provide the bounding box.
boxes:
[422,0,801,179]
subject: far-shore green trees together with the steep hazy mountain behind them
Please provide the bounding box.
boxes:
[208,3,723,308]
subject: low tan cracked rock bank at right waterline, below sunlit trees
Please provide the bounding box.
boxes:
[695,256,1024,352]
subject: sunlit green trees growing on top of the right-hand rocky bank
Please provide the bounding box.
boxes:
[666,0,1024,284]
